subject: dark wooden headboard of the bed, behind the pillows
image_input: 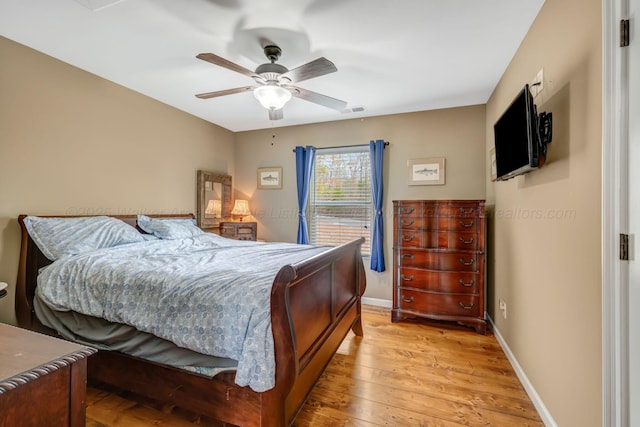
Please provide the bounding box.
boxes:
[15,214,195,334]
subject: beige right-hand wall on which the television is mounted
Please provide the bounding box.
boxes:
[486,0,602,426]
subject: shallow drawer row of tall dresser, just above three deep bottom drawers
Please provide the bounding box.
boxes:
[397,228,478,251]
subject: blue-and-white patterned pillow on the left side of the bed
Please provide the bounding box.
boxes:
[24,216,145,261]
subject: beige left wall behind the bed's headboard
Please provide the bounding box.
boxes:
[0,37,234,323]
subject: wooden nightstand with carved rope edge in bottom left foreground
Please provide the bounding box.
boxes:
[0,323,96,427]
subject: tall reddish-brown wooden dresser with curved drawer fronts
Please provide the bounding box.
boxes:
[391,200,487,334]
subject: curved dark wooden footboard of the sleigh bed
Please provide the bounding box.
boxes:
[271,239,366,424]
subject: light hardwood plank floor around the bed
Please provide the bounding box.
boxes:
[87,306,544,427]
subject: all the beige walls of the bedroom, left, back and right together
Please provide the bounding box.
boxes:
[0,0,602,426]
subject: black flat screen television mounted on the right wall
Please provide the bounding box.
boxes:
[493,85,546,181]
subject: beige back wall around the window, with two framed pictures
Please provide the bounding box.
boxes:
[234,105,485,300]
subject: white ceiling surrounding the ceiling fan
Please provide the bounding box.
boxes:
[0,0,544,131]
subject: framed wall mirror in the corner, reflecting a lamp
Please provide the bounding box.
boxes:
[196,170,232,229]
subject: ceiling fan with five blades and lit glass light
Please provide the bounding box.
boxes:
[196,44,347,120]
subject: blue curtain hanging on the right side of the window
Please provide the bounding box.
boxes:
[369,139,385,271]
